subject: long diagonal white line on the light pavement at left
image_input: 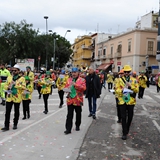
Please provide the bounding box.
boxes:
[0,108,66,144]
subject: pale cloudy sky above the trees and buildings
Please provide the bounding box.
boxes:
[0,0,159,43]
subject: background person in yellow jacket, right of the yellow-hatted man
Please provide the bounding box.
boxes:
[138,71,147,99]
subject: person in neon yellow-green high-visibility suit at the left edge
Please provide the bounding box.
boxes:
[0,63,10,105]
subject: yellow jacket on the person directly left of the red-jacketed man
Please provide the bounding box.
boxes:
[56,75,68,91]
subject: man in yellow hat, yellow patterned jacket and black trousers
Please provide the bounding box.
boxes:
[115,65,139,140]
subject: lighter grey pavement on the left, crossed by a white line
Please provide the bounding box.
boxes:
[0,89,104,160]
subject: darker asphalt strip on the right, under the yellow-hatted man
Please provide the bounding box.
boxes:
[77,86,160,160]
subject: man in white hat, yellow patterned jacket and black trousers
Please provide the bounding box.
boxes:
[1,64,26,131]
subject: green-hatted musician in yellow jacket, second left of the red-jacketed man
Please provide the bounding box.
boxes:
[40,71,52,114]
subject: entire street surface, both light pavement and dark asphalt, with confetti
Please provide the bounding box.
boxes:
[0,86,160,160]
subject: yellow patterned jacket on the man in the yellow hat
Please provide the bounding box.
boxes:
[115,77,139,105]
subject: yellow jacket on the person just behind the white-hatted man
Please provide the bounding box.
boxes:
[22,83,33,100]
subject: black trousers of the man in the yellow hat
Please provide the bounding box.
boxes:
[119,103,134,135]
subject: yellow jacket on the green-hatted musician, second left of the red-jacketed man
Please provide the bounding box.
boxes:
[40,78,52,94]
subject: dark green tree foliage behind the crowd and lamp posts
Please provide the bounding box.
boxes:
[0,20,72,68]
